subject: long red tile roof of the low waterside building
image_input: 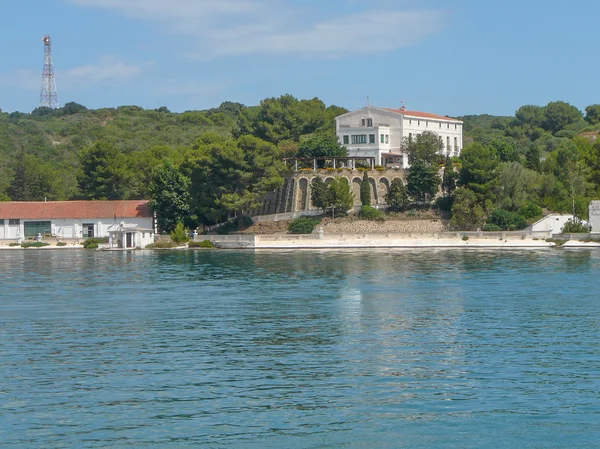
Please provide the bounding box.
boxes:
[0,200,152,220]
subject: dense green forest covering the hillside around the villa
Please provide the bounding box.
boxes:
[0,95,600,229]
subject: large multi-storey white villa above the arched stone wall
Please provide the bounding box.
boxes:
[335,106,463,168]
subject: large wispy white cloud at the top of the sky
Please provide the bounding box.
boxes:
[67,0,445,57]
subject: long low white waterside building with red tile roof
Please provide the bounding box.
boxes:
[0,200,154,244]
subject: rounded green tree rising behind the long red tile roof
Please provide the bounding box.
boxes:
[77,141,132,200]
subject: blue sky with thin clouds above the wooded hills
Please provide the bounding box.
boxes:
[0,0,600,116]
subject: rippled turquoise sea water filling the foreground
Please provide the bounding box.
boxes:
[0,249,600,449]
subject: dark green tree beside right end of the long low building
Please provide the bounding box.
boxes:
[148,160,190,232]
